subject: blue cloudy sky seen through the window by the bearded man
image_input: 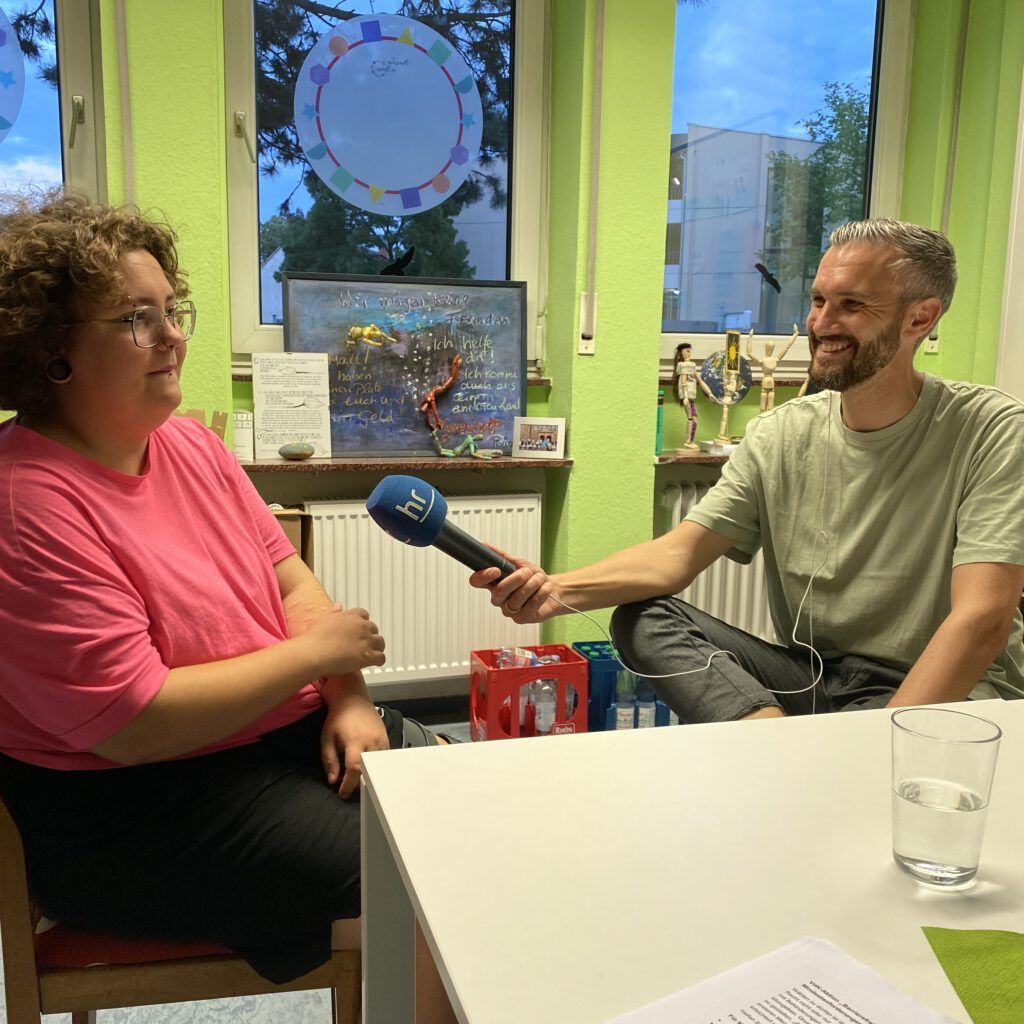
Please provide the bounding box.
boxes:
[672,0,876,138]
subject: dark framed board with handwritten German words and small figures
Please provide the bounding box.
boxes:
[282,272,526,456]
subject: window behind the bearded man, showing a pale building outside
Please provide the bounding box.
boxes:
[662,0,909,364]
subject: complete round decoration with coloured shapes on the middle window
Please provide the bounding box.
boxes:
[295,14,483,217]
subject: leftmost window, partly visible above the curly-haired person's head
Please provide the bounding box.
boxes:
[0,0,104,196]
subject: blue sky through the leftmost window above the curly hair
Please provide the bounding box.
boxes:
[0,0,63,191]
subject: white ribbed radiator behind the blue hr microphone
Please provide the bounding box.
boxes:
[305,493,541,696]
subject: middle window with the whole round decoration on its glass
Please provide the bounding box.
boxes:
[224,0,546,358]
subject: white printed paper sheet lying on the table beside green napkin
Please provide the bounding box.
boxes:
[609,936,957,1024]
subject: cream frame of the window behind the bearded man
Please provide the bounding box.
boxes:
[660,0,914,380]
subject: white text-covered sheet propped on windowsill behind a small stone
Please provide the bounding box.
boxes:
[253,352,331,459]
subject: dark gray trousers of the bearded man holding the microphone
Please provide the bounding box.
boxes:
[611,597,905,722]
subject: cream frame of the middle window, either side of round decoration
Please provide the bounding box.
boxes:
[223,0,549,373]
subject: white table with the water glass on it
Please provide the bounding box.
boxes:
[362,700,1024,1024]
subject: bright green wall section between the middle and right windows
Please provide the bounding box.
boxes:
[545,0,675,641]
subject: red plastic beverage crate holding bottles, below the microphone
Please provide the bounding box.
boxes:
[469,643,587,739]
